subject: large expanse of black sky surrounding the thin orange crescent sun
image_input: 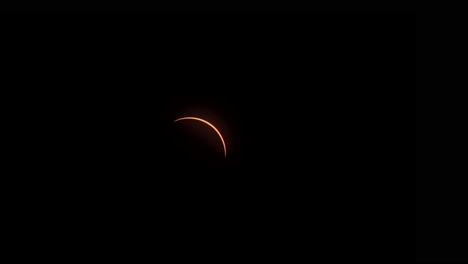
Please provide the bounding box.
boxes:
[3,14,422,259]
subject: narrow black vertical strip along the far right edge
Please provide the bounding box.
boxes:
[416,13,468,262]
